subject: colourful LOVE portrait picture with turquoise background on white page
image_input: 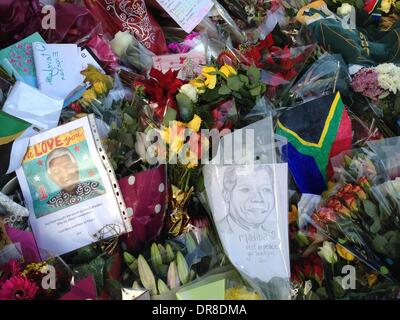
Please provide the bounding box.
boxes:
[23,128,105,218]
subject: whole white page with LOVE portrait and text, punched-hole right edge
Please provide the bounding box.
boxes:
[17,115,132,260]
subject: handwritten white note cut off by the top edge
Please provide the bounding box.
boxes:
[157,0,213,33]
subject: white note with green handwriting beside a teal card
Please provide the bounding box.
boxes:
[33,42,84,99]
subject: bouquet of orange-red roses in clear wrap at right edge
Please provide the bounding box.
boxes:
[311,146,400,283]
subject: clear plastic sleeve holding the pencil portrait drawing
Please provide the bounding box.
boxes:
[203,118,290,299]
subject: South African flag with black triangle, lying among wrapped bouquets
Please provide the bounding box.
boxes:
[277,92,352,194]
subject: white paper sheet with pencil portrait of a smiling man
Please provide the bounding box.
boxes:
[204,164,290,283]
